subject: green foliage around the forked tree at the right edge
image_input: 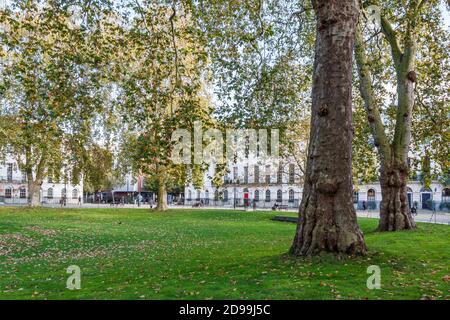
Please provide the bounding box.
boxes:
[354,0,450,177]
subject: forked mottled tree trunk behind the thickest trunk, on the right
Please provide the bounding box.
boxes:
[355,9,417,231]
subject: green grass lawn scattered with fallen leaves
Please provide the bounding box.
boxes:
[0,207,450,299]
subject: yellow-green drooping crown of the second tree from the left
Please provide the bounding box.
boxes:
[108,1,213,194]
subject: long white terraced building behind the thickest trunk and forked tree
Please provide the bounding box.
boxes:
[184,161,450,211]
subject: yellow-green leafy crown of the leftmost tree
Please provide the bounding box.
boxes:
[0,1,115,194]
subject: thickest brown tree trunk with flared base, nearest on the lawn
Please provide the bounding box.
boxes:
[291,0,366,256]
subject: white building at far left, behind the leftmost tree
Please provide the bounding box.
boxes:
[0,158,83,204]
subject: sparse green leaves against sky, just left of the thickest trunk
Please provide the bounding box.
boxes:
[194,1,314,130]
